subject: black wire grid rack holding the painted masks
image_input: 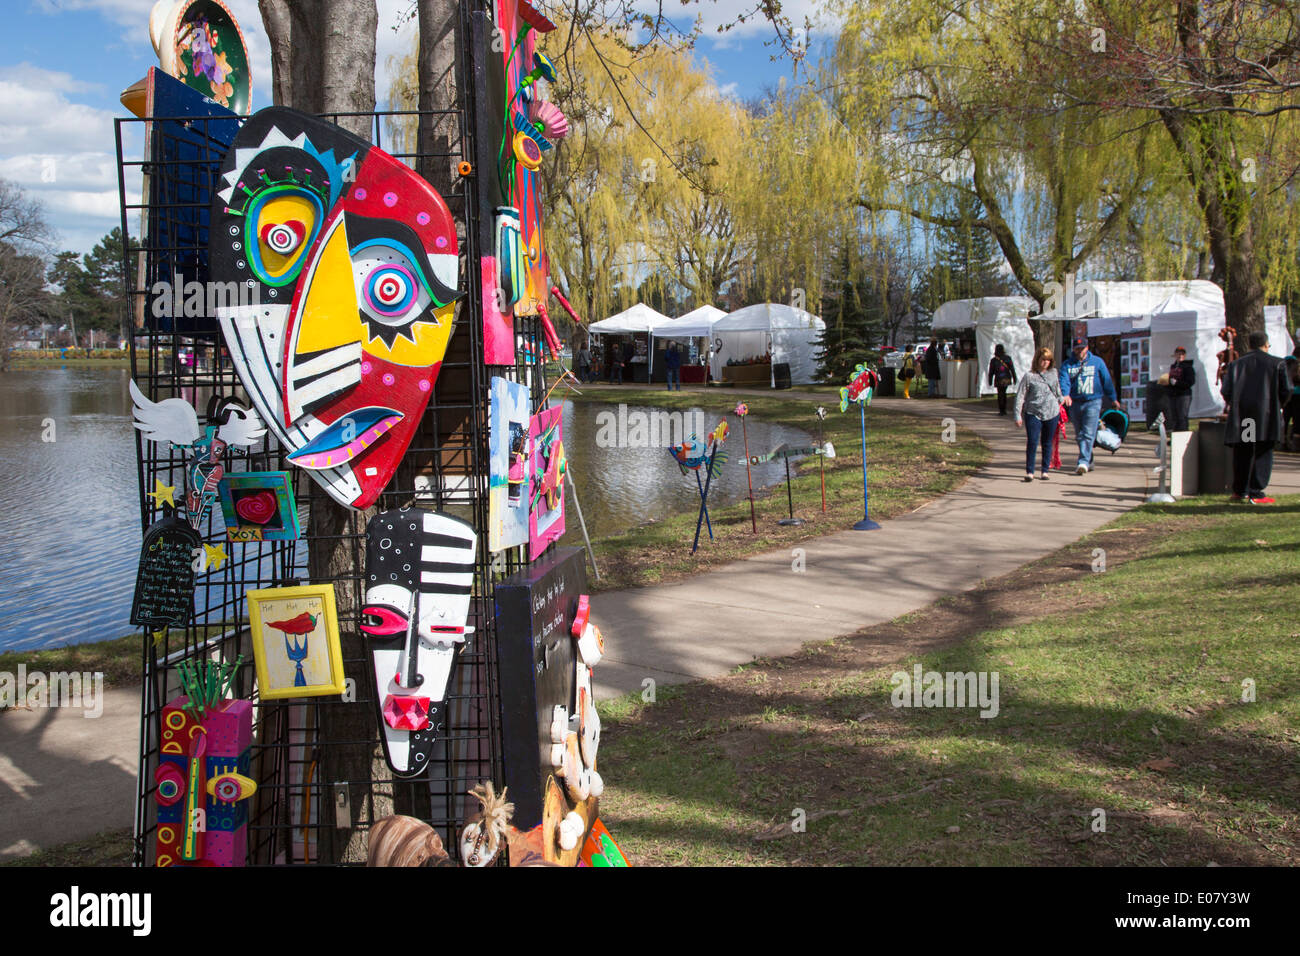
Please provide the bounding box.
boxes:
[116,0,546,865]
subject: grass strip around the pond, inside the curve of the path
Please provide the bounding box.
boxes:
[569,388,989,591]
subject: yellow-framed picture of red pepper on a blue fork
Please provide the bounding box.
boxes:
[244,584,347,700]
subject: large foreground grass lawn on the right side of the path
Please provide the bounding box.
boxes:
[601,497,1300,866]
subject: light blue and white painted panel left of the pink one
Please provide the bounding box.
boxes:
[488,377,533,553]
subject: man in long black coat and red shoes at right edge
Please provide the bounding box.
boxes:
[1219,332,1291,505]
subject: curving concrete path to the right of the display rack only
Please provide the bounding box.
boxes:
[592,389,1300,697]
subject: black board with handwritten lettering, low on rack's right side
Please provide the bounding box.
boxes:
[497,548,586,830]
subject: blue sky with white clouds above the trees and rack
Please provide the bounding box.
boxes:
[0,0,815,252]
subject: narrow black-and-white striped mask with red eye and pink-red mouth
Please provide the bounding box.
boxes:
[361,507,478,777]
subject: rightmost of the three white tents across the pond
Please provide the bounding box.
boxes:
[710,302,826,386]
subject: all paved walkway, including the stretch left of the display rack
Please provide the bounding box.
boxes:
[0,389,1300,860]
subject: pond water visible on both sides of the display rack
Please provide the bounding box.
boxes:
[0,368,809,650]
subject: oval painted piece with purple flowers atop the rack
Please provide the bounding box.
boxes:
[150,0,252,113]
